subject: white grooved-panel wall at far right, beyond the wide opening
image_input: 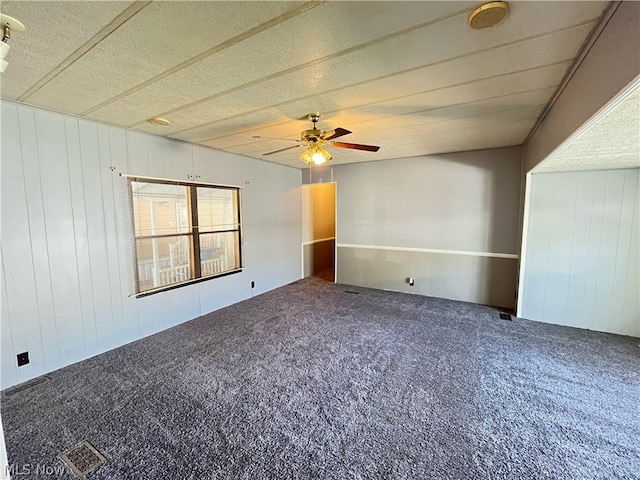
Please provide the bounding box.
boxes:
[518,169,640,336]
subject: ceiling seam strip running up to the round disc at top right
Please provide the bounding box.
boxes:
[127,4,476,128]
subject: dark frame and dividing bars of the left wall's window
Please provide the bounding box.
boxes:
[120,173,245,298]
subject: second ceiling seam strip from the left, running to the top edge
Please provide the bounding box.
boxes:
[80,2,325,116]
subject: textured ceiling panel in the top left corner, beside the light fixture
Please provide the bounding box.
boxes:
[2,0,132,99]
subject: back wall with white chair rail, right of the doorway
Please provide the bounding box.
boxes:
[314,147,522,308]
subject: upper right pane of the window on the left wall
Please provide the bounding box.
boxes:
[197,187,238,232]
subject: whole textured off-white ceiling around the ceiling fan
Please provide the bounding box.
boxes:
[1,0,607,168]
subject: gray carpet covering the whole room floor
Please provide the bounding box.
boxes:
[2,278,640,479]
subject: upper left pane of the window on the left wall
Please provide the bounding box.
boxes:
[131,182,190,237]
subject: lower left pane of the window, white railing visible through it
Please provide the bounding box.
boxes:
[136,235,193,292]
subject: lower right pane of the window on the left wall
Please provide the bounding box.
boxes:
[200,232,240,277]
